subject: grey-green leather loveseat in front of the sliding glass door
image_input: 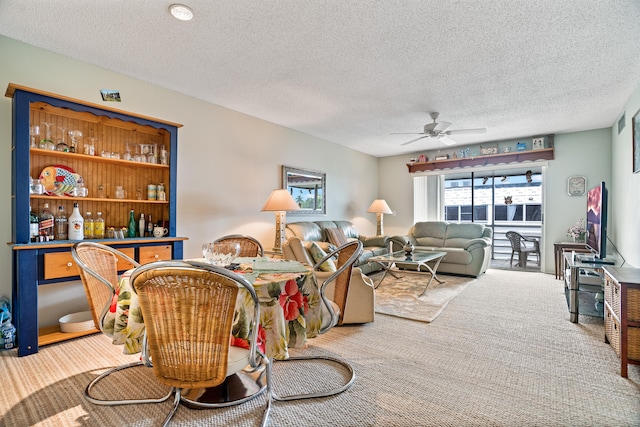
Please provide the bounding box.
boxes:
[391,221,493,277]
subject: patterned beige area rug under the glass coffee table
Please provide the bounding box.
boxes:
[370,272,476,323]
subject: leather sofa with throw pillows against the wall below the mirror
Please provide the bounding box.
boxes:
[283,221,389,274]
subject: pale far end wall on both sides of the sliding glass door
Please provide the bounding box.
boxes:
[379,128,616,273]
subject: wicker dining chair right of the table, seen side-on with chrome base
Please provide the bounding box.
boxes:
[267,240,362,401]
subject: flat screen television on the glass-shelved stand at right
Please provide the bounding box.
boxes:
[583,182,608,262]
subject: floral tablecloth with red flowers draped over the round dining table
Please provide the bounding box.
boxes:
[103,258,322,359]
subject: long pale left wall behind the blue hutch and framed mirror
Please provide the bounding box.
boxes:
[0,36,378,326]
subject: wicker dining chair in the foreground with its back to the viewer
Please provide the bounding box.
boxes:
[131,261,270,426]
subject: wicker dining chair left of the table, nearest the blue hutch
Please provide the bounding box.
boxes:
[71,242,171,405]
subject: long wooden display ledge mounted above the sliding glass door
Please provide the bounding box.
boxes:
[407,148,554,173]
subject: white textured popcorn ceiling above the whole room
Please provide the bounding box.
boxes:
[0,0,640,157]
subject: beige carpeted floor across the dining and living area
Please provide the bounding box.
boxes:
[0,270,640,427]
